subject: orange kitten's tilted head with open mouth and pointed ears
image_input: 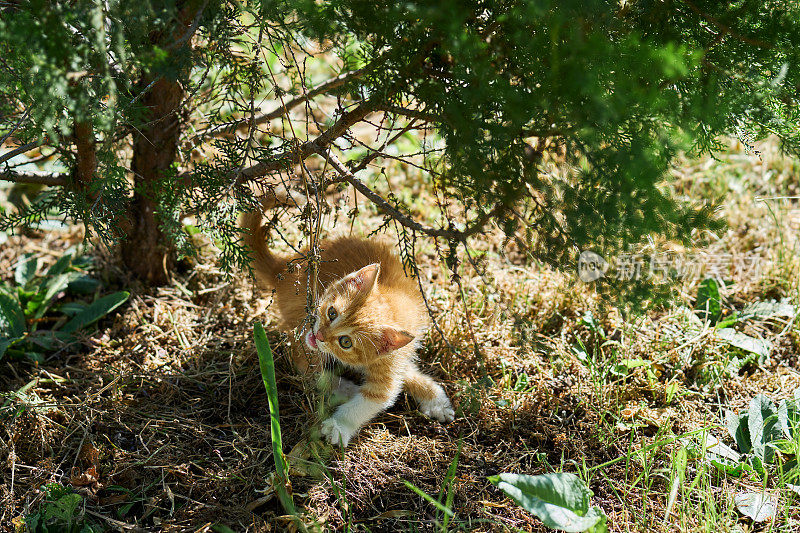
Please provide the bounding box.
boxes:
[305,263,414,365]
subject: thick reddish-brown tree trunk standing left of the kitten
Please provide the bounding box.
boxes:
[121,78,183,285]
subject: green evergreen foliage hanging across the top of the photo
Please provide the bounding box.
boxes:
[0,0,800,280]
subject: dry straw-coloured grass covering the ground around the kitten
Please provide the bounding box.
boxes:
[0,138,800,532]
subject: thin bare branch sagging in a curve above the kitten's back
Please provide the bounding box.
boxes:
[314,145,496,242]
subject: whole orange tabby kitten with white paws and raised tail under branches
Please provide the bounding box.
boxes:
[242,208,454,446]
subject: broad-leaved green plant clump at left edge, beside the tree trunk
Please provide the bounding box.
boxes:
[0,252,128,361]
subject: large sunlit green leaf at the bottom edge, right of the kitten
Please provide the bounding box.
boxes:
[489,473,605,532]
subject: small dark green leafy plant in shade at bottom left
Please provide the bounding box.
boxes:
[25,483,104,533]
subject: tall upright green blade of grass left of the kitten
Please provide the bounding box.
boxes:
[253,322,299,522]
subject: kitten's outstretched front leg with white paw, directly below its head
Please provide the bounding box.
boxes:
[322,370,402,446]
